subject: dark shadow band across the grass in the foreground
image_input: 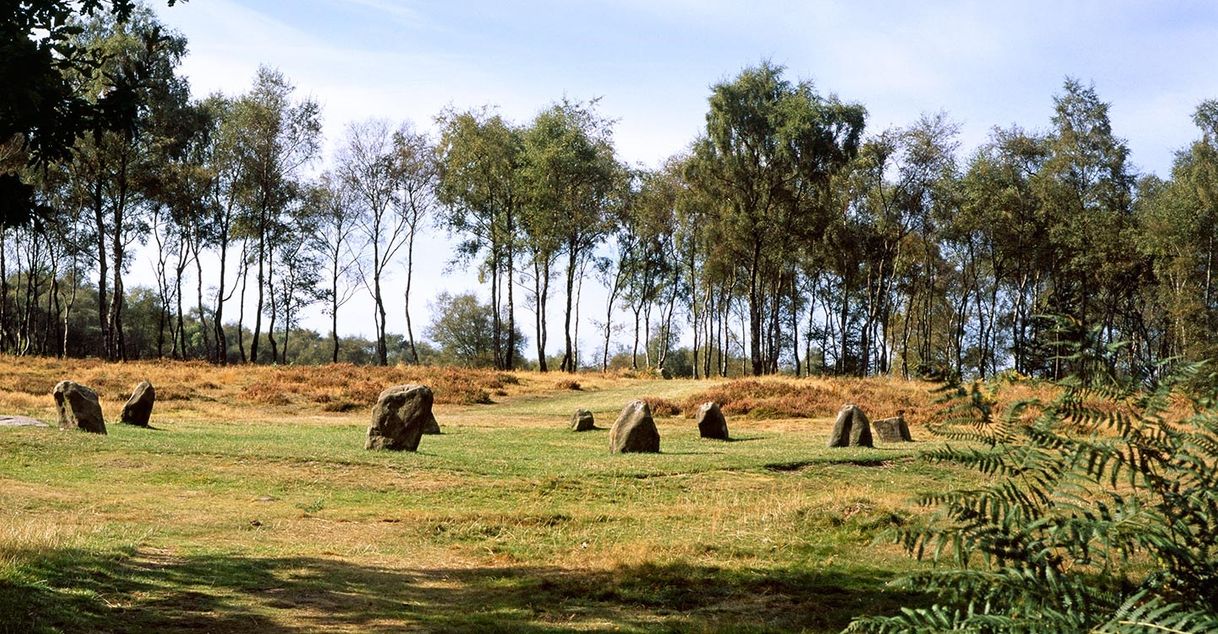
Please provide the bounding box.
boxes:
[0,550,924,634]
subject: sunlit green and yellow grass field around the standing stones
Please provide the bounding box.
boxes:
[0,358,963,633]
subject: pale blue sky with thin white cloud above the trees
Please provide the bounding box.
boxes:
[144,0,1218,360]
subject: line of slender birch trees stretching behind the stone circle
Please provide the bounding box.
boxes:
[0,2,1218,378]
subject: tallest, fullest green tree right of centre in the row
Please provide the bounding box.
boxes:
[694,62,866,375]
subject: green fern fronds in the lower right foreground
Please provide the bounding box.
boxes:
[850,332,1218,632]
